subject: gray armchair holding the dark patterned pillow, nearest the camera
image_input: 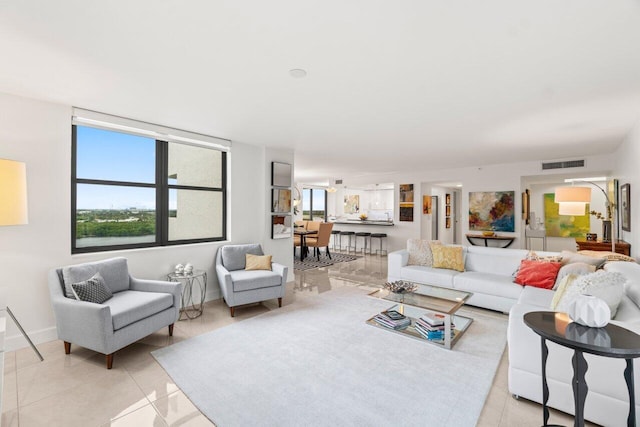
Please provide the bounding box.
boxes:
[49,258,182,369]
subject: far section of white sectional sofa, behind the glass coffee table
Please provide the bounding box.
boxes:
[388,246,559,313]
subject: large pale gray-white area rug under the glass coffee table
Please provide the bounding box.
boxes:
[152,288,507,427]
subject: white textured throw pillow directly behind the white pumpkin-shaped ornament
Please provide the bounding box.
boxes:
[556,271,626,318]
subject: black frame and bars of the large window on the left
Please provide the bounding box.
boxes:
[71,124,228,254]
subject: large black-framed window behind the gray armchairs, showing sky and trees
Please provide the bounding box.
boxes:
[71,125,226,253]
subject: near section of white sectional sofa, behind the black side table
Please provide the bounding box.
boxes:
[507,261,640,426]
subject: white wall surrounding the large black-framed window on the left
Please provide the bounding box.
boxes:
[0,94,293,350]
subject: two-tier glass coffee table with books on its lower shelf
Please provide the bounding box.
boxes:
[366,284,473,349]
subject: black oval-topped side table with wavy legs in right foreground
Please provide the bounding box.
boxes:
[524,311,640,427]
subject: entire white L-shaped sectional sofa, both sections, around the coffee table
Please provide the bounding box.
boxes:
[388,242,640,426]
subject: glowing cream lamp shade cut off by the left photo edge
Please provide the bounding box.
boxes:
[0,159,28,225]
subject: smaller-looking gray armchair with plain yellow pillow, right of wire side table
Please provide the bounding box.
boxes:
[216,244,288,317]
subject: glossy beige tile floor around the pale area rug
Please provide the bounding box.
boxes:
[2,252,592,427]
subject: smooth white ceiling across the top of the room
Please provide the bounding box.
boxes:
[0,0,640,182]
